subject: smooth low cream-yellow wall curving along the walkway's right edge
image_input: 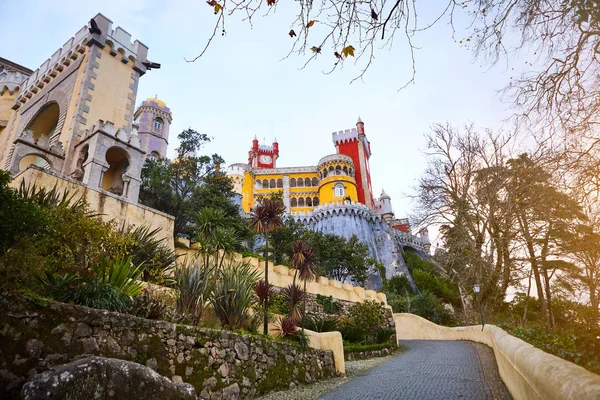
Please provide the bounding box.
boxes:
[394,314,600,400]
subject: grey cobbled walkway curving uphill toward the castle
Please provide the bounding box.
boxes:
[320,340,511,400]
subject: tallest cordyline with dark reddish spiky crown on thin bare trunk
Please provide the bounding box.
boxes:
[250,199,285,335]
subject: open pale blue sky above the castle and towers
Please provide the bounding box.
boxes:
[0,0,521,247]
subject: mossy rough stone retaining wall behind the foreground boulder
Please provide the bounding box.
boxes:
[0,295,335,399]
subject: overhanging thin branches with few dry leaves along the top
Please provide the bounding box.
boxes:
[190,0,600,137]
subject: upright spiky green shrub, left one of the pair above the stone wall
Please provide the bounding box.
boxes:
[175,258,215,325]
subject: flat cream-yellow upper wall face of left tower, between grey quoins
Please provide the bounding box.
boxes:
[87,45,133,129]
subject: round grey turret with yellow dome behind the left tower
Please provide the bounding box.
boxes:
[134,97,173,158]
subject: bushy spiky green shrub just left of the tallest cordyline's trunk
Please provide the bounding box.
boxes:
[211,263,259,329]
